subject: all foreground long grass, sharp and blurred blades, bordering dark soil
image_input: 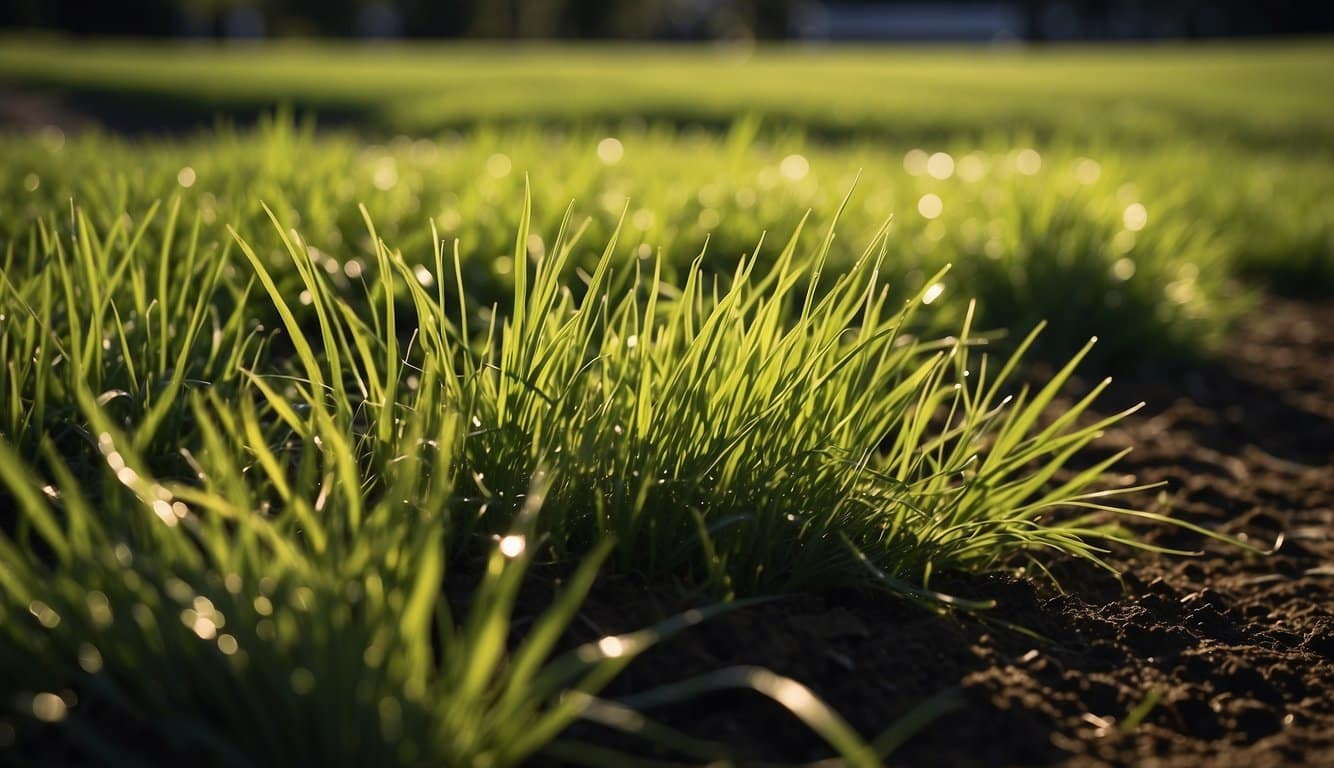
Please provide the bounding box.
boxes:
[0,180,1189,764]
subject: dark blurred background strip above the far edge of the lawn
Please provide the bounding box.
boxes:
[0,0,1334,41]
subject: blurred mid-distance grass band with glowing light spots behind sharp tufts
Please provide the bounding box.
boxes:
[0,120,1280,368]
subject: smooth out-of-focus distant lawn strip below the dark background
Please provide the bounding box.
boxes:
[0,39,1334,148]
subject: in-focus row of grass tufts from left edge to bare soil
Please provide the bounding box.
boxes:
[3,186,1157,593]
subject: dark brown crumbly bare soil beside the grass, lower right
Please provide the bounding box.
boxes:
[546,299,1334,768]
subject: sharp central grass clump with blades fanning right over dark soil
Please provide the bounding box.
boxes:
[394,190,1157,592]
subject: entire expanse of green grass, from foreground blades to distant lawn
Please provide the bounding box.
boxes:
[0,40,1334,765]
